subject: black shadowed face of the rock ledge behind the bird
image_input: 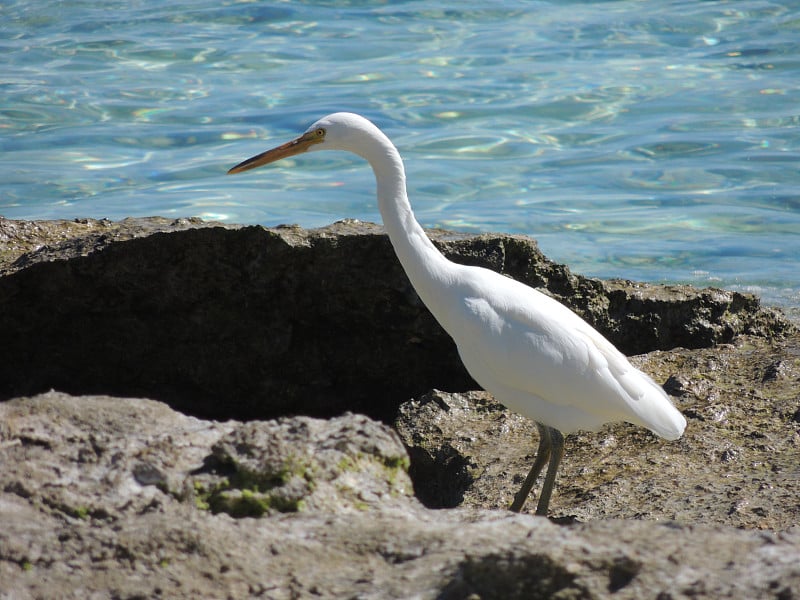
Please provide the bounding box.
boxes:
[0,227,475,420]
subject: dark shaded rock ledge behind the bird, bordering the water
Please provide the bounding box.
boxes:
[0,218,791,422]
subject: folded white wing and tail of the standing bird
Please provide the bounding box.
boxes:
[456,274,683,438]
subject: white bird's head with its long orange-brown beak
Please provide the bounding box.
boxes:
[228,112,384,174]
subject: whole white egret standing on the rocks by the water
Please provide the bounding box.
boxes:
[229,113,686,515]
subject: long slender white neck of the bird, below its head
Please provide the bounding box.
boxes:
[359,132,455,312]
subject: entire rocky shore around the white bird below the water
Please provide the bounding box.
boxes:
[0,218,800,600]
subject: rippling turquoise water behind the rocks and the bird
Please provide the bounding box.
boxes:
[0,0,800,310]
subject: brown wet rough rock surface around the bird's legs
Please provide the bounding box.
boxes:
[396,334,800,531]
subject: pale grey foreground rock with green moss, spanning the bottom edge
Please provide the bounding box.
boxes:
[0,392,800,600]
